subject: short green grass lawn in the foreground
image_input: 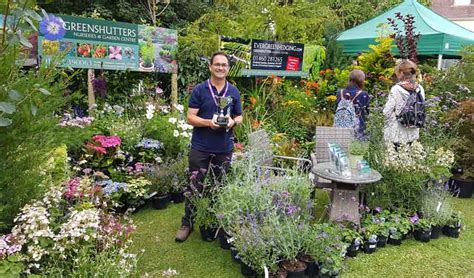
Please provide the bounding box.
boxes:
[133,194,474,278]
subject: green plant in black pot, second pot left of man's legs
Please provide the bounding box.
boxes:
[145,165,170,209]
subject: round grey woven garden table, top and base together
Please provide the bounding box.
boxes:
[311,162,382,225]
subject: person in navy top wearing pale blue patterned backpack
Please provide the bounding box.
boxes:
[334,70,369,140]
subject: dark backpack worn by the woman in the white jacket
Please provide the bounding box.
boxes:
[397,86,426,128]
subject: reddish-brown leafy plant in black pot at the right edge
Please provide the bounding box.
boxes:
[449,98,474,198]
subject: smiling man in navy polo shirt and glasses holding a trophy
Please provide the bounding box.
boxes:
[176,52,242,242]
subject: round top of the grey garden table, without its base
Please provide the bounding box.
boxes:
[311,162,382,184]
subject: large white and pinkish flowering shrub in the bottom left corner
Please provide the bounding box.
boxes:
[0,177,139,277]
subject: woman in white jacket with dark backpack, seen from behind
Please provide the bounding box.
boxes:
[383,59,425,146]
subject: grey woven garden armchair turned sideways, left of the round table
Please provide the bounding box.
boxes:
[248,129,311,176]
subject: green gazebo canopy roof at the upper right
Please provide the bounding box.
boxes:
[337,0,474,56]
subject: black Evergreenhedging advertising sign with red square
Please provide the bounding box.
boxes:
[250,40,304,71]
